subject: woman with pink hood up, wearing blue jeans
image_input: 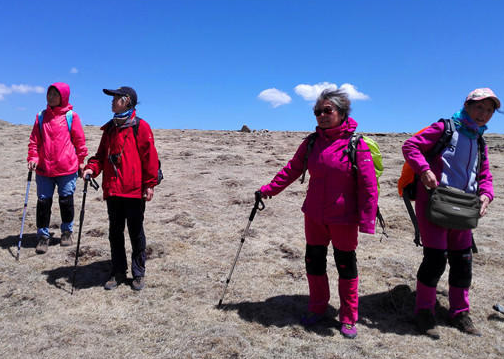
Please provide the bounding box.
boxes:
[27,82,87,254]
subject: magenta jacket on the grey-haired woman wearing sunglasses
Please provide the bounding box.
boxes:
[261,117,378,234]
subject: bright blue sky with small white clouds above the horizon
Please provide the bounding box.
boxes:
[0,0,504,133]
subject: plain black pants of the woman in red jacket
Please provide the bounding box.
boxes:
[107,197,146,277]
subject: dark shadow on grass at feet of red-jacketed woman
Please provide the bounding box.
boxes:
[42,260,111,291]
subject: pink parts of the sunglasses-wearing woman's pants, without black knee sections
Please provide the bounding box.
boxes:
[305,215,359,324]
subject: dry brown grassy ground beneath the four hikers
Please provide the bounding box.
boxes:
[0,122,504,359]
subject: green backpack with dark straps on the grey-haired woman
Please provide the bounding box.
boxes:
[301,132,388,237]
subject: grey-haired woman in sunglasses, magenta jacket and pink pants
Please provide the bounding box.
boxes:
[260,90,378,338]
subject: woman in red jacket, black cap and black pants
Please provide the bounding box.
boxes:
[83,86,159,290]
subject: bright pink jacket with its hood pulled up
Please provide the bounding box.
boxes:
[27,82,88,177]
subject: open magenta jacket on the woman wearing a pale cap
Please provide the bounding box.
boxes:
[402,122,494,201]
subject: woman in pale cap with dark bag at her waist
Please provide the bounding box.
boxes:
[402,88,500,339]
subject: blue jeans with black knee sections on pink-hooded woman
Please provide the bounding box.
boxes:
[36,172,78,237]
